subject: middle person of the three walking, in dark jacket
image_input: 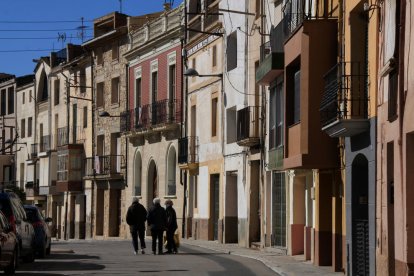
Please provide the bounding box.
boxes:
[147,198,167,255]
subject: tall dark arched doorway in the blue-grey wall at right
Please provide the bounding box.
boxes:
[352,154,369,275]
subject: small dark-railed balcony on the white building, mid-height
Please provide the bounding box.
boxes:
[237,106,261,147]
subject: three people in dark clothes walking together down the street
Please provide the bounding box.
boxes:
[126,197,178,255]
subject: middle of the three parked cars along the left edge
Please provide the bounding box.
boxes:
[0,190,35,262]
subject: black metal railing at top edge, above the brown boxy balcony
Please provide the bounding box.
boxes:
[282,0,338,39]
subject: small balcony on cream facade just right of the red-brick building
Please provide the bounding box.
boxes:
[178,136,199,171]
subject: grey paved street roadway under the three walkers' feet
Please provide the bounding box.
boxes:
[16,240,277,276]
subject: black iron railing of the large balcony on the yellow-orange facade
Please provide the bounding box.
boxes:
[319,62,369,126]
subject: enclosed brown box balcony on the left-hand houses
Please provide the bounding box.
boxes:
[56,144,84,192]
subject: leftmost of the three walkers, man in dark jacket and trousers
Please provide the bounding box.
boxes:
[126,197,147,255]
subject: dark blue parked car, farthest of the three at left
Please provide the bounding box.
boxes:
[24,205,52,258]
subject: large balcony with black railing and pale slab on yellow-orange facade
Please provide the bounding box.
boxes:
[319,62,370,137]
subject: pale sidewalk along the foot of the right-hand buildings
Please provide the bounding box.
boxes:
[181,239,344,276]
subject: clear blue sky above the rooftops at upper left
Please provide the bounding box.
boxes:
[0,0,183,76]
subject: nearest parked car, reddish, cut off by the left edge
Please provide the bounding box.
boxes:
[0,212,19,274]
